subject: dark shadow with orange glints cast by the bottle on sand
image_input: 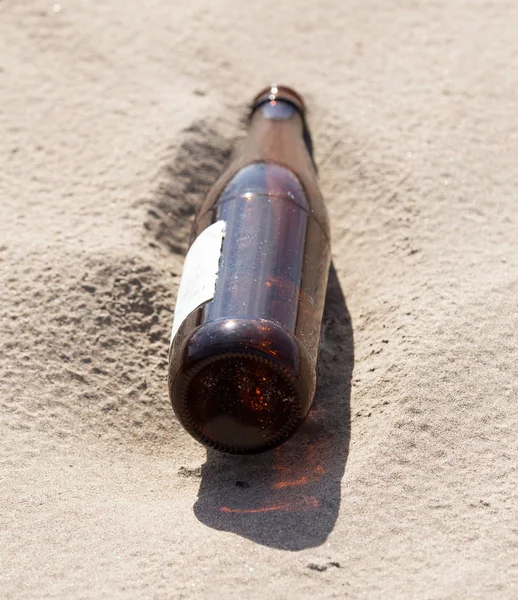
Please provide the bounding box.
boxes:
[194,265,354,551]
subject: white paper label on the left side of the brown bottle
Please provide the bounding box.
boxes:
[171,221,226,344]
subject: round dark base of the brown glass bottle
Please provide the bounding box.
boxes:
[175,352,305,454]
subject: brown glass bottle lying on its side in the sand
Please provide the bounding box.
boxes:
[169,86,330,454]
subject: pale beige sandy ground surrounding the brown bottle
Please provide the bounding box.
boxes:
[0,0,518,600]
